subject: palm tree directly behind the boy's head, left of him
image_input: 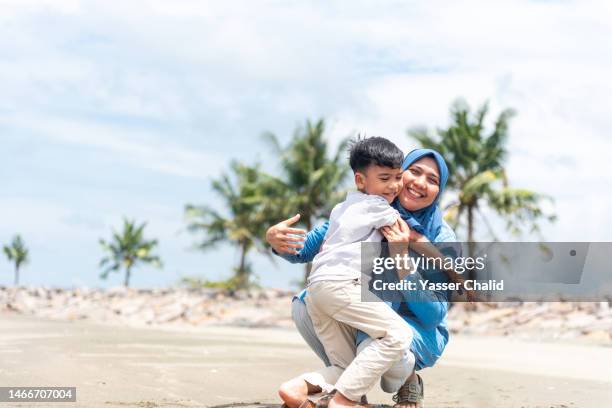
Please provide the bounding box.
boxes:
[264,119,349,280]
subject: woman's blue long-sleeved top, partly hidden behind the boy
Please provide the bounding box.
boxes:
[279,222,459,369]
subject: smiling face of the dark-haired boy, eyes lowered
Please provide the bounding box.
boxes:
[355,165,402,203]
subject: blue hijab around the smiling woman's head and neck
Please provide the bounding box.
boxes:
[391,149,448,242]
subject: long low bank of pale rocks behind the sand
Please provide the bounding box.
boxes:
[0,286,612,346]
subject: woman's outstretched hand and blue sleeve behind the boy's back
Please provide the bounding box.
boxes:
[266,214,329,263]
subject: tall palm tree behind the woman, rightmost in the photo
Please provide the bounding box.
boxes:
[408,100,555,252]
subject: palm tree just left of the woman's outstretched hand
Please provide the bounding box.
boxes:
[185,161,280,289]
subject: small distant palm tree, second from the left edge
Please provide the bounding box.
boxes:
[100,218,162,287]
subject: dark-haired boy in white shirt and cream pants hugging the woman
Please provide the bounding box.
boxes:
[279,137,412,408]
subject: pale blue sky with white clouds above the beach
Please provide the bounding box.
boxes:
[0,0,612,288]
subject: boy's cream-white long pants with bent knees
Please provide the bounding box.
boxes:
[303,280,412,401]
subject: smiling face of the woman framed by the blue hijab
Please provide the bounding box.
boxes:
[399,156,440,211]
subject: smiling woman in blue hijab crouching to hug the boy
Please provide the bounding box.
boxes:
[266,149,456,408]
